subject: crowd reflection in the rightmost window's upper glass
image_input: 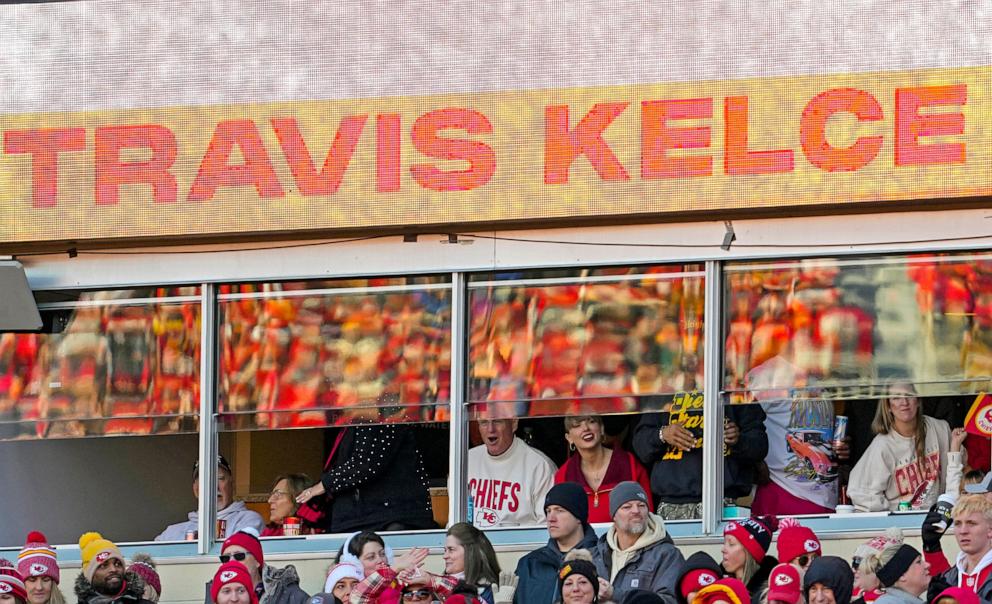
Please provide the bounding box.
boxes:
[724,254,992,402]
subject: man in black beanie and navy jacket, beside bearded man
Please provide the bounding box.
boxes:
[513,482,596,604]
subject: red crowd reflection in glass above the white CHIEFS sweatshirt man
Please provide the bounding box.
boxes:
[469,266,703,417]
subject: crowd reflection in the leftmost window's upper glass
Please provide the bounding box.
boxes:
[0,288,200,440]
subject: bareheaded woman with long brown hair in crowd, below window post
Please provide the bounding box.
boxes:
[444,522,500,604]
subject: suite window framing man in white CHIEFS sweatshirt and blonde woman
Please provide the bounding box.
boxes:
[467,266,704,528]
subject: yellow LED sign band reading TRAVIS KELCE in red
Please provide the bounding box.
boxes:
[0,67,992,248]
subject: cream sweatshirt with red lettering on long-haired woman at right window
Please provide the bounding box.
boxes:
[847,416,964,512]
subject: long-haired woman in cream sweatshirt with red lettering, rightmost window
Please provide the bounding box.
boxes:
[847,382,966,512]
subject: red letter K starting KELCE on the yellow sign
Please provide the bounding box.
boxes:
[544,103,630,185]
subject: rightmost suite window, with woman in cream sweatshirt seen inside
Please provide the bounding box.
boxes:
[724,253,992,517]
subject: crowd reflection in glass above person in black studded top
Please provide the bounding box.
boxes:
[219,278,451,429]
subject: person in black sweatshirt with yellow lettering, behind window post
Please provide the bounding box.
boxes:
[633,394,768,520]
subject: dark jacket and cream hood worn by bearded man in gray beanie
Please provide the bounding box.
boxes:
[592,513,685,604]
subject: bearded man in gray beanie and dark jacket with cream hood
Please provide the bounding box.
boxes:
[593,481,685,604]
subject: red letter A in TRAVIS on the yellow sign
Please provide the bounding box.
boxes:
[189,120,284,201]
